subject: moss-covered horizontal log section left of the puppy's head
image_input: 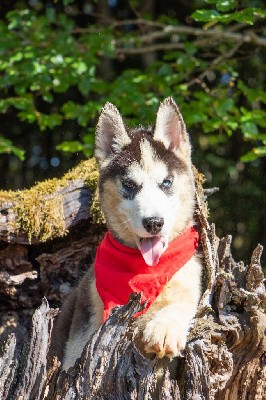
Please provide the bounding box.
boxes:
[0,158,104,244]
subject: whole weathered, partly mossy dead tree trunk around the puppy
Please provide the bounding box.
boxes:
[0,164,266,400]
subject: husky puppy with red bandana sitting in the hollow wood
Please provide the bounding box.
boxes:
[51,97,202,369]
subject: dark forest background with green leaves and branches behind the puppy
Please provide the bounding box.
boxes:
[0,0,266,268]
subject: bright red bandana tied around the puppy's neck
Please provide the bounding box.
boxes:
[95,228,199,321]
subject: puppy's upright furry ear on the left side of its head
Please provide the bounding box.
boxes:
[94,103,131,167]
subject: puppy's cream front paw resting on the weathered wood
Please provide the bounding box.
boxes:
[138,318,188,358]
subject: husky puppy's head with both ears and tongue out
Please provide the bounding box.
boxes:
[95,98,195,265]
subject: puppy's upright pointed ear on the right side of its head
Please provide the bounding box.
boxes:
[154,97,191,157]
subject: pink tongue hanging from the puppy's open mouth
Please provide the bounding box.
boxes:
[140,236,166,267]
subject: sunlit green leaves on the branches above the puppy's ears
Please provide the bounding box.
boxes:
[0,0,266,161]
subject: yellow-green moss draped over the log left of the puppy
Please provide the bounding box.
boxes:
[0,158,104,241]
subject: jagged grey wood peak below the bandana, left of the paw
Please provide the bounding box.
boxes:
[44,295,160,400]
